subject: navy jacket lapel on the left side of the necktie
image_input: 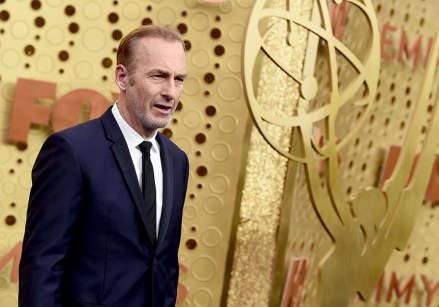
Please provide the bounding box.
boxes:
[101,108,155,247]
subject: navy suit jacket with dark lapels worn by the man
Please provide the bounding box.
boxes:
[19,109,189,307]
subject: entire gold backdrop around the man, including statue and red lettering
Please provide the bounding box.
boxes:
[0,0,439,307]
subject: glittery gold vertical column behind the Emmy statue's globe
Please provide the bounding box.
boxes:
[227,0,312,306]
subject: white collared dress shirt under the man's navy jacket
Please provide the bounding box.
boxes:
[111,102,163,235]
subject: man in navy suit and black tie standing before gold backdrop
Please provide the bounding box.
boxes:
[19,25,189,307]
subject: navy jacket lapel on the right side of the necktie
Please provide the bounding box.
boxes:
[157,133,174,248]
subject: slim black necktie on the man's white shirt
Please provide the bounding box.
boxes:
[139,141,156,244]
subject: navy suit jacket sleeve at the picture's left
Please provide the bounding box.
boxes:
[19,133,82,307]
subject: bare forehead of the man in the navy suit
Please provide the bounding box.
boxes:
[134,37,186,73]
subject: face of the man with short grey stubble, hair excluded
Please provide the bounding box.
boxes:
[125,38,186,134]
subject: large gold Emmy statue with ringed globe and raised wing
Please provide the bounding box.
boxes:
[244,0,439,307]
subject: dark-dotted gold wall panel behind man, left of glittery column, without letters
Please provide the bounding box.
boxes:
[0,0,253,307]
